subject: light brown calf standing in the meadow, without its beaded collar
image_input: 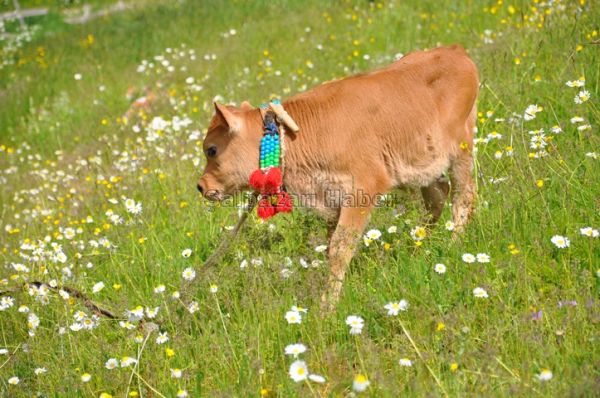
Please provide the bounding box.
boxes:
[198,46,479,306]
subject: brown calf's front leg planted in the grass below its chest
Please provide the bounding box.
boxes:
[321,206,371,312]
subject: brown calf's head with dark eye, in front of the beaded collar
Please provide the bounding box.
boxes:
[198,102,262,200]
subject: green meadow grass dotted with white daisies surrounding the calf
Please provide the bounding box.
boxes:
[0,0,600,397]
